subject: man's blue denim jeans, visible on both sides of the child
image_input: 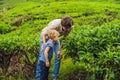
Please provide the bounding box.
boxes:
[36,36,61,79]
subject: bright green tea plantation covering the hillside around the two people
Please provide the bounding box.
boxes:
[0,0,120,80]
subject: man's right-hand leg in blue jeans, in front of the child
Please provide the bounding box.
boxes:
[53,41,60,79]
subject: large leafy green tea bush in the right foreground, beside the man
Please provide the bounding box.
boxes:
[64,23,120,80]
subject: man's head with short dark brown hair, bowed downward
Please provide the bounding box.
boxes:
[61,16,74,31]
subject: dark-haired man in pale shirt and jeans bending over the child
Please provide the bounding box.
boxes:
[40,16,74,80]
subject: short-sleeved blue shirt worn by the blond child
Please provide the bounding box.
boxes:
[40,40,54,62]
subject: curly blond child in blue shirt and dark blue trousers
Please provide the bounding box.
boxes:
[36,30,59,80]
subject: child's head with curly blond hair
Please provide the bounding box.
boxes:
[47,30,60,42]
